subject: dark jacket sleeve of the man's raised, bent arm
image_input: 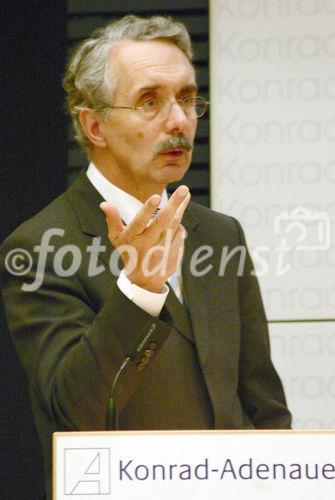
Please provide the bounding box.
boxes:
[0,231,172,430]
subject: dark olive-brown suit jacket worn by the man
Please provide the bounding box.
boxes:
[1,173,290,496]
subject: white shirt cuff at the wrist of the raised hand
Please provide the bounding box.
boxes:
[117,270,169,316]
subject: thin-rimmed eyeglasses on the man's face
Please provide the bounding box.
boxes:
[108,96,209,120]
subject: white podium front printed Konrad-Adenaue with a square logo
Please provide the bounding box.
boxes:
[53,431,335,500]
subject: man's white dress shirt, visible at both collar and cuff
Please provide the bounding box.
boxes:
[86,162,171,316]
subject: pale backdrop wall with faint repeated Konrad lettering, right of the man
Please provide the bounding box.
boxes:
[210,0,335,428]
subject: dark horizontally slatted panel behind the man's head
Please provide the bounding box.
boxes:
[68,0,209,206]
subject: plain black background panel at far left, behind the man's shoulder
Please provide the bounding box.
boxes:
[0,0,67,500]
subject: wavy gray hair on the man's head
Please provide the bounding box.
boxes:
[63,15,193,155]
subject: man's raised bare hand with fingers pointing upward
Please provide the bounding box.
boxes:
[100,186,191,292]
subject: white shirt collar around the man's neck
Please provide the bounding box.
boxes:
[86,162,168,224]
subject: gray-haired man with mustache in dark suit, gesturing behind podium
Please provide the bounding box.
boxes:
[1,16,290,495]
